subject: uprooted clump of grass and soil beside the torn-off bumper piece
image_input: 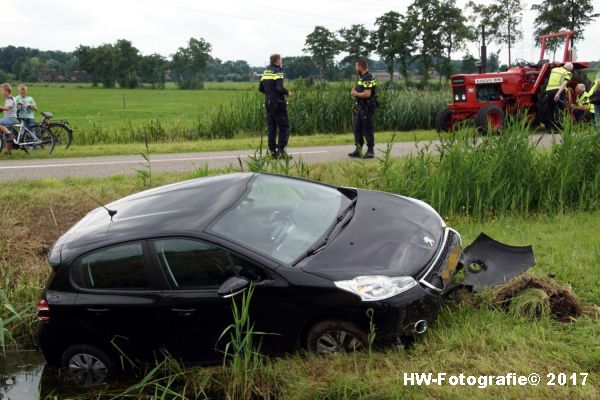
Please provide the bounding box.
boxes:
[490,274,598,322]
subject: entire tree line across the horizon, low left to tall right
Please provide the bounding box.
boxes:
[0,0,600,89]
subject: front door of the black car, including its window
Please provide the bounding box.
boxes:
[151,238,268,361]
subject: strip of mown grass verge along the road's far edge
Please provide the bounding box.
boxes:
[0,130,439,161]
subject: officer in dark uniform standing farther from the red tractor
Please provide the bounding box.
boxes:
[258,54,292,158]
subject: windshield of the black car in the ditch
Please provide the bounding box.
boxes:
[211,175,350,263]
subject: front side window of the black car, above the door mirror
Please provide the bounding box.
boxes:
[154,238,265,290]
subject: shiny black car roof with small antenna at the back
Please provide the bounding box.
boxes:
[49,173,255,266]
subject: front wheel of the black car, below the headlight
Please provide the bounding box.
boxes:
[306,320,368,355]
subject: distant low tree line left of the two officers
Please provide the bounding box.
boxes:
[0,38,253,89]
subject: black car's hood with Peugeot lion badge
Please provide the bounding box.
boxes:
[299,190,444,280]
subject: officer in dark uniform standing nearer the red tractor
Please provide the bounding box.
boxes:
[348,58,377,158]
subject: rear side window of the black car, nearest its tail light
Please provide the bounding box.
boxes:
[80,243,150,290]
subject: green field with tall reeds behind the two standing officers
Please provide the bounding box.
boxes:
[9,81,448,145]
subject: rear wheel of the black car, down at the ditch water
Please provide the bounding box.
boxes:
[60,344,119,385]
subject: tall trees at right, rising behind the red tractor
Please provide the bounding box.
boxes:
[304,0,600,82]
